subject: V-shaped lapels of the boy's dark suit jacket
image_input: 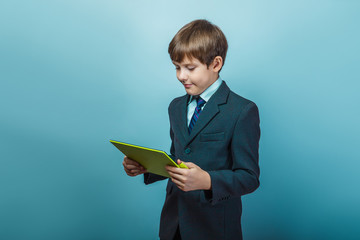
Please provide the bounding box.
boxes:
[186,81,230,146]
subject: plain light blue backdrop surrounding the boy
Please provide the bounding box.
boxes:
[0,0,360,240]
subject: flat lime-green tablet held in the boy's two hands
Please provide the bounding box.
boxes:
[110,140,188,177]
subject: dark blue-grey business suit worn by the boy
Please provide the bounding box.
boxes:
[144,82,260,240]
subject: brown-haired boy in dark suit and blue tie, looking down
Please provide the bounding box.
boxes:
[123,20,260,240]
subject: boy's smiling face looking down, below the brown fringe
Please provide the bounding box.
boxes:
[173,57,222,95]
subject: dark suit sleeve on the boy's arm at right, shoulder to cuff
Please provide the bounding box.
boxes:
[202,102,260,205]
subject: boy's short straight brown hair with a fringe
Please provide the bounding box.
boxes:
[168,19,228,70]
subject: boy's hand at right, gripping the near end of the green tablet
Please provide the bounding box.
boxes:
[165,159,211,192]
